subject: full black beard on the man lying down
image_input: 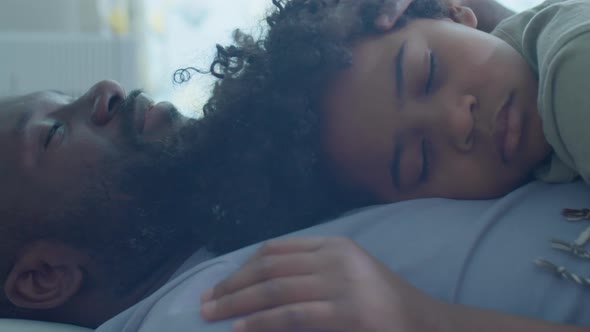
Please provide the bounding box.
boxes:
[38,121,202,294]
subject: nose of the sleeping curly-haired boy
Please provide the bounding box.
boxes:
[441,95,477,152]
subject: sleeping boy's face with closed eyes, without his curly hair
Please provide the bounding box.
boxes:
[322,19,550,201]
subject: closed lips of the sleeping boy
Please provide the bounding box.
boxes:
[494,92,522,163]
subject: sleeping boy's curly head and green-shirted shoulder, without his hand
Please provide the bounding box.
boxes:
[206,0,590,203]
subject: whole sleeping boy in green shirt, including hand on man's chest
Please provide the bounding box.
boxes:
[202,0,590,331]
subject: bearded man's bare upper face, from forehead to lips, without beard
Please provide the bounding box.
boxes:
[0,81,190,211]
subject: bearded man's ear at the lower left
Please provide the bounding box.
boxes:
[4,241,88,309]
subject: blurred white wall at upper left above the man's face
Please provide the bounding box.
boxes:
[0,0,141,97]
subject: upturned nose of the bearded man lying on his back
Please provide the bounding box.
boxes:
[85,80,125,126]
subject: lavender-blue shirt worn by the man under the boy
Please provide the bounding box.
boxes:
[98,182,590,332]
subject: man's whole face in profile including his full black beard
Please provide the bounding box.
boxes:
[0,81,201,288]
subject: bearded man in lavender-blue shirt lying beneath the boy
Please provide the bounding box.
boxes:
[0,81,590,331]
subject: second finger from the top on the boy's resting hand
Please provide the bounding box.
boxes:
[206,252,317,302]
